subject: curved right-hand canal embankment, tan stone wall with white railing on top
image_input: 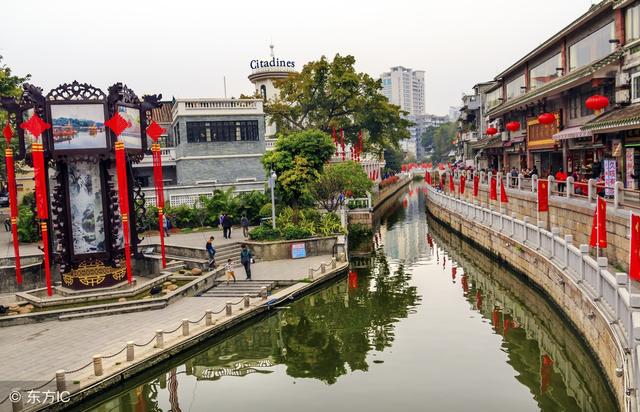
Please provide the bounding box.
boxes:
[427,188,638,411]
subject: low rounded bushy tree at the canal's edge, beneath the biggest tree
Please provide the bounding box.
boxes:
[309,161,373,212]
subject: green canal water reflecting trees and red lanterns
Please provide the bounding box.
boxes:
[81,185,617,412]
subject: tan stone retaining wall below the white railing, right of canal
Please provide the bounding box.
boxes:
[428,194,636,410]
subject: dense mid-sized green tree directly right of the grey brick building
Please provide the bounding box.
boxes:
[262,130,335,217]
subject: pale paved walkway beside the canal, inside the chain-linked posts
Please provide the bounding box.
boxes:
[0,255,331,386]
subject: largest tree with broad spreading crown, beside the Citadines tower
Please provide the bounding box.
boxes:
[265,54,411,153]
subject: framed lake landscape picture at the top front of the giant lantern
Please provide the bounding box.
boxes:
[51,104,107,150]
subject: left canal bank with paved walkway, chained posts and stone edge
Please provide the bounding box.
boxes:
[0,255,348,411]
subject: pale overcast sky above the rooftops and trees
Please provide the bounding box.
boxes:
[0,0,592,114]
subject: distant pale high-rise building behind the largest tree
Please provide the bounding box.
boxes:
[380,66,425,116]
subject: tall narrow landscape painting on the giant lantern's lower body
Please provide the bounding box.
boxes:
[68,162,105,255]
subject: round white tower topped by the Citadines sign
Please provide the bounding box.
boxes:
[249,44,297,150]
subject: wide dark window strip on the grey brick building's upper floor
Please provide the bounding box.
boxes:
[187,120,260,143]
